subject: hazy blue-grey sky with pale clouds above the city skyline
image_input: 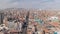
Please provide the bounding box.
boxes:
[0,0,60,9]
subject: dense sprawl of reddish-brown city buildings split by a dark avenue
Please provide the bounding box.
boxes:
[0,8,60,34]
